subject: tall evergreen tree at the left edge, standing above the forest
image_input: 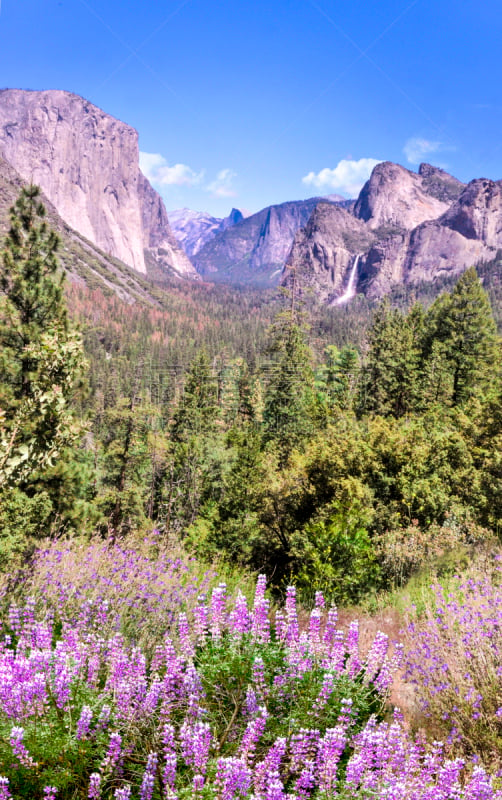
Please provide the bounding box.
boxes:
[0,186,84,542]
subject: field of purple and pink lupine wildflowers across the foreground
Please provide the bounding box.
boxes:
[0,537,502,800]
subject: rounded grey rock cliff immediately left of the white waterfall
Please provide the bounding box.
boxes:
[281,202,375,303]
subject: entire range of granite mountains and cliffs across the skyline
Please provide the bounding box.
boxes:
[0,89,496,305]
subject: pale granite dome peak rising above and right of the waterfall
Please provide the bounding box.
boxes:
[354,161,449,230]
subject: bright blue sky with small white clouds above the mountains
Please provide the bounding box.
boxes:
[0,0,502,216]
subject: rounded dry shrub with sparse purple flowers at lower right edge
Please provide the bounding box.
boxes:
[406,557,502,766]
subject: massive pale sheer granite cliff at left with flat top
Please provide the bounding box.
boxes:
[0,89,193,274]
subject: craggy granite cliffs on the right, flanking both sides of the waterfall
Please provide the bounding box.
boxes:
[282,163,502,302]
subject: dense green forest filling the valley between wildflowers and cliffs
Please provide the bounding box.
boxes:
[0,188,502,603]
